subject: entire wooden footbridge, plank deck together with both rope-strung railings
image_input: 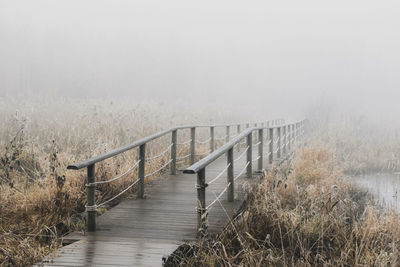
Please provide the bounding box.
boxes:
[37,120,304,266]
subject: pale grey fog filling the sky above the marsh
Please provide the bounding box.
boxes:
[0,0,400,123]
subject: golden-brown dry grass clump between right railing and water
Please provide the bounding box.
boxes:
[168,147,400,266]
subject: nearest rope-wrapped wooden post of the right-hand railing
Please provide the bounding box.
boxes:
[197,168,207,236]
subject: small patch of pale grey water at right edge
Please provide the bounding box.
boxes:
[352,173,400,211]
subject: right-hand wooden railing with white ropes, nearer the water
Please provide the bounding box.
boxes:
[183,120,305,235]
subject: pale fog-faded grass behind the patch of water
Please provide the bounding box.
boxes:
[308,117,400,174]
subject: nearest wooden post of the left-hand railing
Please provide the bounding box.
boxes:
[86,164,96,232]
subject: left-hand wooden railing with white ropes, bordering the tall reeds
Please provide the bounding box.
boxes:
[67,119,304,232]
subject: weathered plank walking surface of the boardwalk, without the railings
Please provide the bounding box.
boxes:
[37,156,258,266]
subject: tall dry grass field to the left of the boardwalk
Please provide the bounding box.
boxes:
[0,98,241,266]
